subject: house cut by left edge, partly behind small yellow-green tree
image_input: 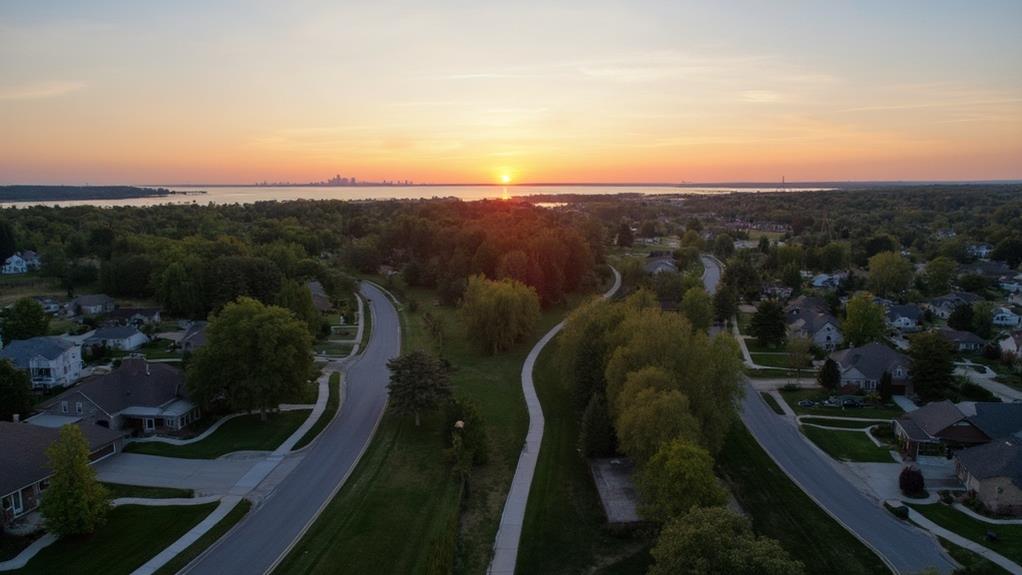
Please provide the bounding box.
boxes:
[0,421,123,528]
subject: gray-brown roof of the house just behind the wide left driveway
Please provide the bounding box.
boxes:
[45,357,188,414]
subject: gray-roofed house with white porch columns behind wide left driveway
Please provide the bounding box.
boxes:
[36,357,200,434]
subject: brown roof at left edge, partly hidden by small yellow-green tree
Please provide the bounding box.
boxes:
[0,422,121,495]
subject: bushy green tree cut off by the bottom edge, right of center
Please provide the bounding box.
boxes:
[648,508,804,575]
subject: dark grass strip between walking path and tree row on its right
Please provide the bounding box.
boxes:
[517,339,650,574]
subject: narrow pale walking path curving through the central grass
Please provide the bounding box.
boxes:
[486,267,621,575]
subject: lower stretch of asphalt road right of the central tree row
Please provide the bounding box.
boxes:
[742,386,954,573]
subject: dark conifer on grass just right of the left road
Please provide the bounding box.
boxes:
[387,350,451,427]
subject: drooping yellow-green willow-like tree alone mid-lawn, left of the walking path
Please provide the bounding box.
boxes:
[461,276,540,353]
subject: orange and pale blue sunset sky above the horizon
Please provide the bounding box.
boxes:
[0,0,1022,184]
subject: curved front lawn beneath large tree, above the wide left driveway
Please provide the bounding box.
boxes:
[125,410,310,460]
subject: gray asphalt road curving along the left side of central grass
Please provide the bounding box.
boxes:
[187,283,401,575]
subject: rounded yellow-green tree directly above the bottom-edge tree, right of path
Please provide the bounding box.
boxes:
[636,438,728,522]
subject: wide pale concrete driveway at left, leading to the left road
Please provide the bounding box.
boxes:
[93,453,255,495]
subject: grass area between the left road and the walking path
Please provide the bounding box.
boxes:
[276,289,596,574]
